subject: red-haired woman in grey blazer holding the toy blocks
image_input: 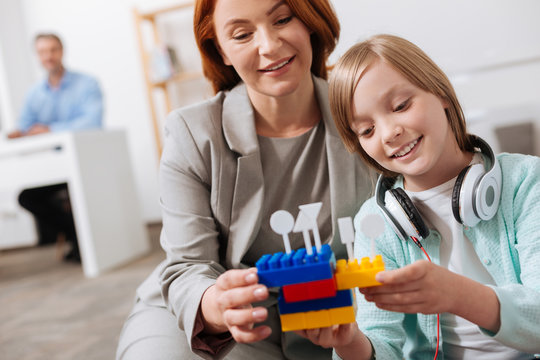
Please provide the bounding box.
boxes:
[117,0,370,359]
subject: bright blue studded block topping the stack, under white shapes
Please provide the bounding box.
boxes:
[255,244,336,287]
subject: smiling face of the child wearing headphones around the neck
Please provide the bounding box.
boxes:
[351,60,467,191]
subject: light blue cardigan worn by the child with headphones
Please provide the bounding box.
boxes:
[334,154,540,360]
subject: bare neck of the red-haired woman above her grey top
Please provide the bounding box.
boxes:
[252,76,321,137]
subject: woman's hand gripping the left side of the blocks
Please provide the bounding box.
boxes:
[201,268,271,343]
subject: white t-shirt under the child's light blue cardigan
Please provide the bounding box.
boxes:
[406,154,530,360]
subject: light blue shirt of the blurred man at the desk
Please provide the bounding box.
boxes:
[19,70,103,132]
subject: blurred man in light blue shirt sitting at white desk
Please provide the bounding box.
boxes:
[8,34,103,261]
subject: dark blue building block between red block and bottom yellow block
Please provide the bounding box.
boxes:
[278,289,353,315]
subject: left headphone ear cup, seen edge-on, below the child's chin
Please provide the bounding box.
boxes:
[386,188,429,239]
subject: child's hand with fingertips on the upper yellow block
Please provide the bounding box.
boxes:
[359,260,462,314]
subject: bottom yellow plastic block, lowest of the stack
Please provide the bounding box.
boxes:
[280,306,355,331]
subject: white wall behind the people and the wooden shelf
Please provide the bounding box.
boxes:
[0,0,540,221]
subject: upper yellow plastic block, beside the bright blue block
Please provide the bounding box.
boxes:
[335,255,384,290]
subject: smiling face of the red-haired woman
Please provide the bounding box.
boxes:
[214,0,312,97]
